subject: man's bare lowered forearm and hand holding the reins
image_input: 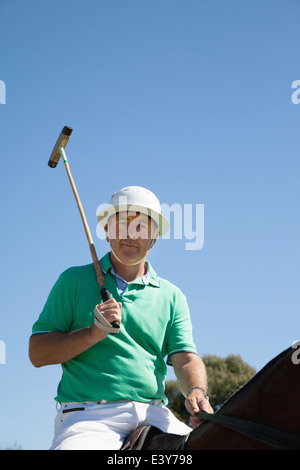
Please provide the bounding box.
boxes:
[171,352,213,427]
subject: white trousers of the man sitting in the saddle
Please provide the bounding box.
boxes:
[50,401,192,450]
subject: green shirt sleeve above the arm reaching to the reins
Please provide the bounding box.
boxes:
[167,290,197,365]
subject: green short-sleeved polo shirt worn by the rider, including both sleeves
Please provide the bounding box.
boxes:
[32,253,197,404]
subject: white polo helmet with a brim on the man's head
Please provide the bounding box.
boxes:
[97,186,170,235]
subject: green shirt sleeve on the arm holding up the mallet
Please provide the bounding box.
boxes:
[32,271,74,335]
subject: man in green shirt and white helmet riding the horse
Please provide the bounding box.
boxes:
[29,186,212,450]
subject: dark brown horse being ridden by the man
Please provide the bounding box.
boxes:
[127,348,300,451]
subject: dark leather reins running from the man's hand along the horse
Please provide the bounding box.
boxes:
[185,411,300,450]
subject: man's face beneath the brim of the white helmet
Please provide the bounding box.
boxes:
[106,211,158,265]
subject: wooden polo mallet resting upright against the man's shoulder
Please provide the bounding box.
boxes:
[48,126,120,333]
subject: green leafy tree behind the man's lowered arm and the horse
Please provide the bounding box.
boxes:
[166,354,256,424]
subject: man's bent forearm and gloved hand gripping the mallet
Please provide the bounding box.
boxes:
[29,299,121,367]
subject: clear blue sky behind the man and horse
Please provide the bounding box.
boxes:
[0,0,300,449]
